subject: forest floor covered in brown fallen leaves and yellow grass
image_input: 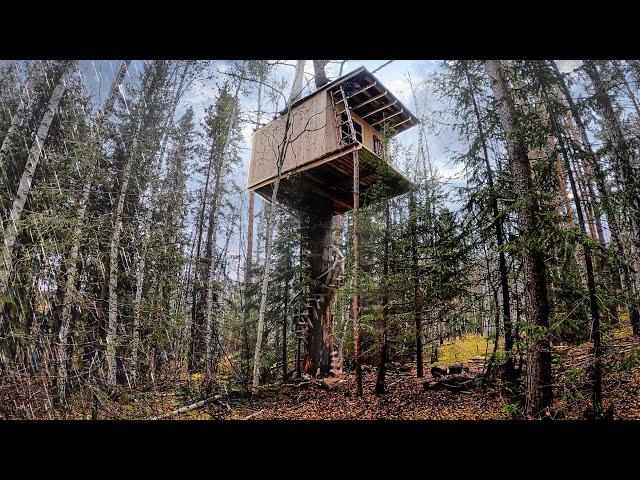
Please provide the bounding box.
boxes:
[89,331,640,420]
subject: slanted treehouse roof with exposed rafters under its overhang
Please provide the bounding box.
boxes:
[280,66,420,135]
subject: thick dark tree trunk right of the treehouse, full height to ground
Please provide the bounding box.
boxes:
[485,60,552,416]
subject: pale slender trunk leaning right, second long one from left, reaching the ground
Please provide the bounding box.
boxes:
[58,60,131,403]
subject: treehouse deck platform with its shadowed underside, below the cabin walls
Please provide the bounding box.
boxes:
[253,145,411,215]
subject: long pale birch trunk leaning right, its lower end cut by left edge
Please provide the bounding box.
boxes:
[0,61,76,294]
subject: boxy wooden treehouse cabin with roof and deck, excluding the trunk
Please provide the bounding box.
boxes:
[248,67,418,215]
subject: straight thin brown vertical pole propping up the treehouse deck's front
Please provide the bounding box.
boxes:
[353,150,362,397]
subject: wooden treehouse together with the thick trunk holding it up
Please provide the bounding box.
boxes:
[248,67,418,376]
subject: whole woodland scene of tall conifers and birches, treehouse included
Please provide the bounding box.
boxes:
[0,59,640,420]
